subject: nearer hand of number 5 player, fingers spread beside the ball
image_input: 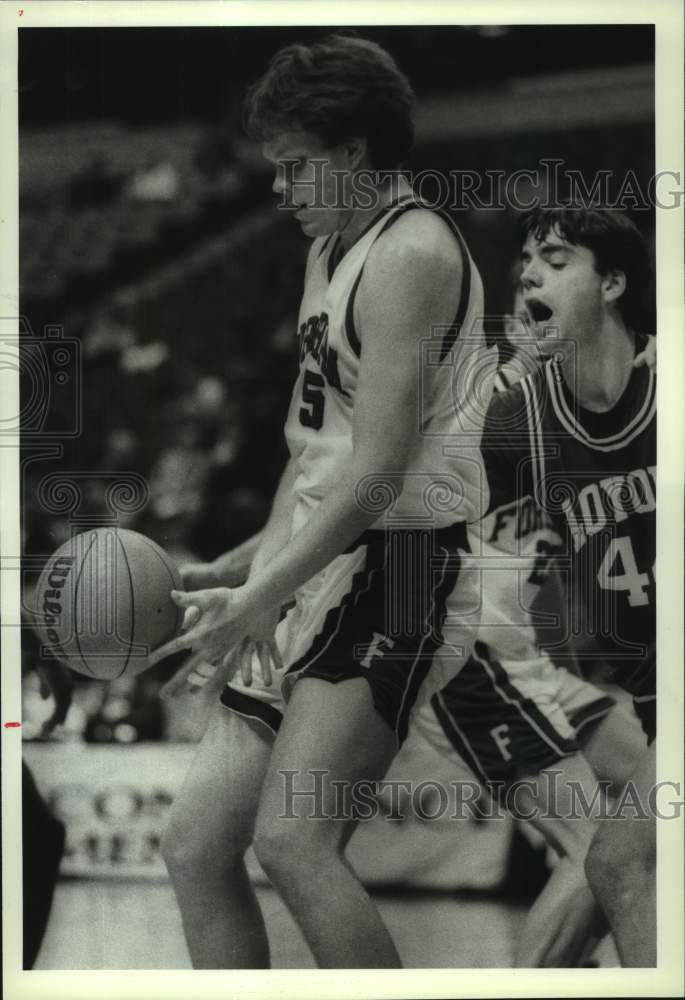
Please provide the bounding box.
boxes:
[149,587,262,666]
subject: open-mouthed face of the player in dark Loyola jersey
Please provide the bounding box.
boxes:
[521,230,605,350]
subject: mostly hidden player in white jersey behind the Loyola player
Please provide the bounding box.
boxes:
[412,267,653,967]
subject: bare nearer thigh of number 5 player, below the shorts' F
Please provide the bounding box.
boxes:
[255,677,397,859]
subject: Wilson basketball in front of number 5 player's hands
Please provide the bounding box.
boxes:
[36,527,183,681]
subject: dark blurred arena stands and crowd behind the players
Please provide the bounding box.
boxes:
[20,26,654,743]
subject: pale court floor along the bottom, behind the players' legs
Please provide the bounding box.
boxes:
[35,879,526,969]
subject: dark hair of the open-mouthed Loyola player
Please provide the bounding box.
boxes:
[518,207,652,329]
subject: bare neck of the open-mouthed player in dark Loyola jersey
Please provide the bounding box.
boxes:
[562,317,635,413]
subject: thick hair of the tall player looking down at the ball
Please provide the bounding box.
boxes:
[245,35,414,170]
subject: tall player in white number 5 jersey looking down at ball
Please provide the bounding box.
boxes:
[152,36,496,968]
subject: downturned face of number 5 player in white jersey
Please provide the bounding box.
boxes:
[264,132,351,239]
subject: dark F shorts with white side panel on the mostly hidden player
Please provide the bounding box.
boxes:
[415,641,616,787]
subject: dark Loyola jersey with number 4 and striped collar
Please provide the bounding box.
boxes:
[482,342,656,697]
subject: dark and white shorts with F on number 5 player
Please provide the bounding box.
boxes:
[221,524,477,745]
